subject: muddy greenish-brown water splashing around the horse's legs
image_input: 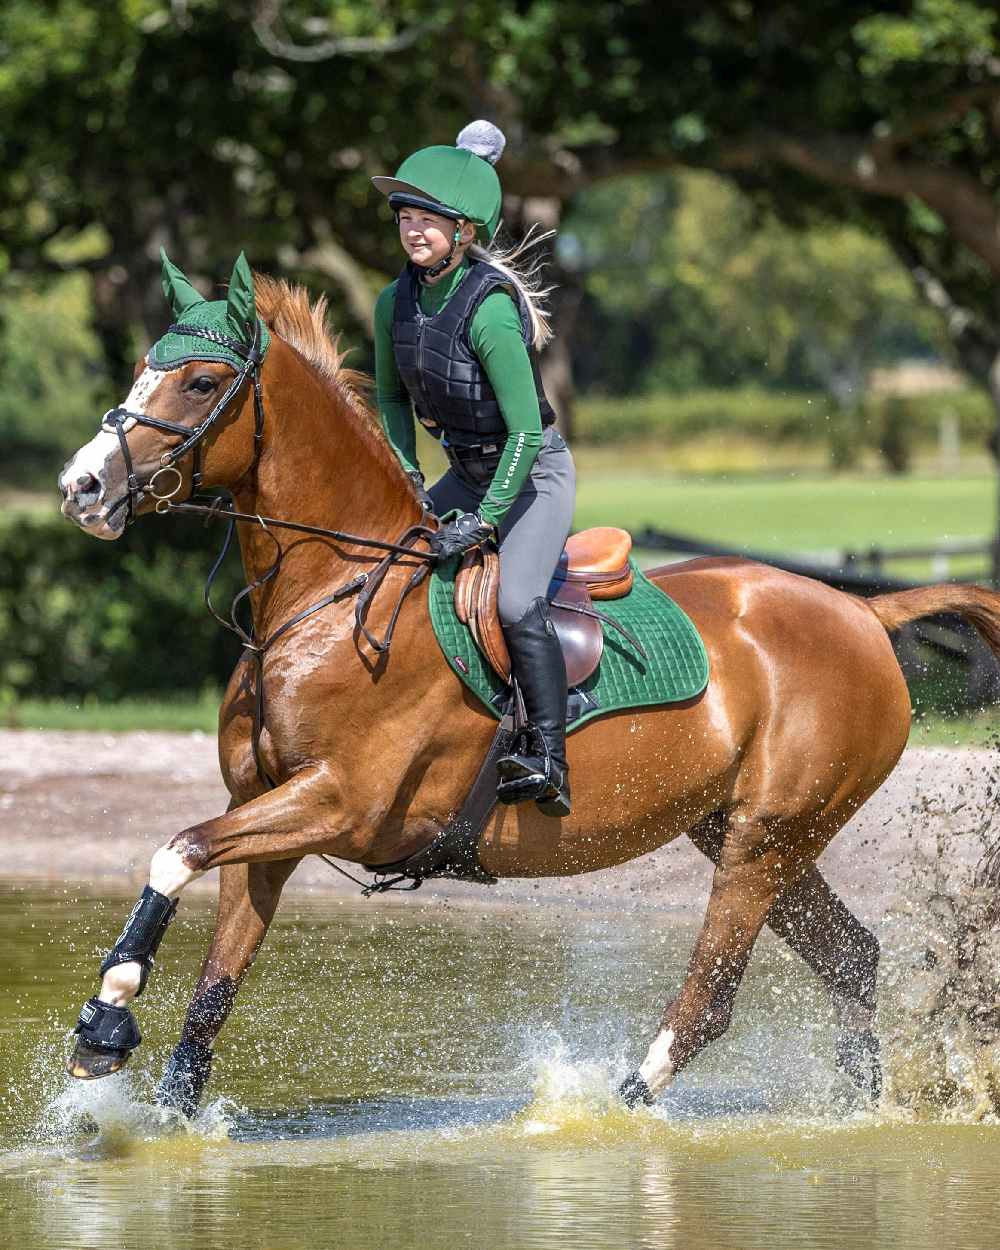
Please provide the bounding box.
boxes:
[0,886,1000,1250]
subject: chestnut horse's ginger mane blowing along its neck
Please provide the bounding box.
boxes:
[254,274,413,490]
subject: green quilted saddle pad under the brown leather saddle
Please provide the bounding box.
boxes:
[430,559,709,731]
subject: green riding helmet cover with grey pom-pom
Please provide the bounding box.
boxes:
[371,121,506,243]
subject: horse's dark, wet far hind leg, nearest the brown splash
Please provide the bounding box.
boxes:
[690,819,881,1100]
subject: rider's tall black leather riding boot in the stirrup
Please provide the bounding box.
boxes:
[496,599,570,816]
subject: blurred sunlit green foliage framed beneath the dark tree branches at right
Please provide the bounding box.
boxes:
[560,173,943,397]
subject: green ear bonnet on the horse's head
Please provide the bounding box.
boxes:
[146,248,271,373]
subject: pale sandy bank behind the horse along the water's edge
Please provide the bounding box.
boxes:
[0,730,1000,918]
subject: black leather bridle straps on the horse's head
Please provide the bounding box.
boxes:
[101,320,264,526]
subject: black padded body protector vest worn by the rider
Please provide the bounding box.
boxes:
[393,258,555,461]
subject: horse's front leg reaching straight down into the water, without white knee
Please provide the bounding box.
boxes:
[156,859,300,1116]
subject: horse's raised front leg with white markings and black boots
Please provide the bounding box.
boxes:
[66,769,340,1080]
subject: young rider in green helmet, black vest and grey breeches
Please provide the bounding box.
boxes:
[373,121,576,816]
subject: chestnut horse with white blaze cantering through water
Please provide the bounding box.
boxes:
[60,256,1000,1114]
